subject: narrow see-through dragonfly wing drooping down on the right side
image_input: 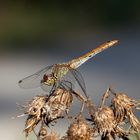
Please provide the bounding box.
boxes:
[70,69,88,98]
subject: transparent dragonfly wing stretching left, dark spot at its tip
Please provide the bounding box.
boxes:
[18,65,53,89]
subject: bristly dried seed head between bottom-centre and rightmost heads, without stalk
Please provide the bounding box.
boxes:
[93,107,127,140]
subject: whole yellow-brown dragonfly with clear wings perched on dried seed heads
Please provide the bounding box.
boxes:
[18,40,118,98]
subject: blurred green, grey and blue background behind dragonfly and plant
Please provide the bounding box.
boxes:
[0,0,140,140]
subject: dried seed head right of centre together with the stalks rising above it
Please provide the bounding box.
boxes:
[87,89,130,140]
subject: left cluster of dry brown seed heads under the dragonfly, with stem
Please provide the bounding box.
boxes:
[21,88,85,137]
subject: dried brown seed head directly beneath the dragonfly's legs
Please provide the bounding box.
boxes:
[43,88,73,125]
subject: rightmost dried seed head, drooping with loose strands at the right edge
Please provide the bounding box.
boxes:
[112,94,140,132]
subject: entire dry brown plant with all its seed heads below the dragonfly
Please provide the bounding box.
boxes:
[18,88,140,140]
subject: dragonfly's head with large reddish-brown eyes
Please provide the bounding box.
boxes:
[41,74,56,86]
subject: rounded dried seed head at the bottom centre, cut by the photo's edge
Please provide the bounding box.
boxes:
[63,117,93,140]
